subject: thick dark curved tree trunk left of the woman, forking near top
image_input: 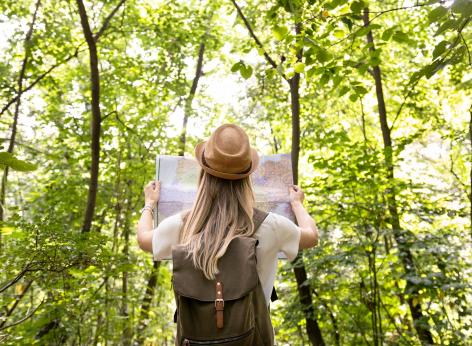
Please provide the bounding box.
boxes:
[77,0,101,232]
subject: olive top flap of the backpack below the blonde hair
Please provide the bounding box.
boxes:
[172,237,259,302]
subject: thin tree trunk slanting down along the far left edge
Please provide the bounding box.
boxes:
[0,0,41,252]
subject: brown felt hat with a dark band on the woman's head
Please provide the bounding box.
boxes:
[195,124,259,180]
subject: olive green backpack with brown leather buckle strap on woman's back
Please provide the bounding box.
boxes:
[172,209,274,346]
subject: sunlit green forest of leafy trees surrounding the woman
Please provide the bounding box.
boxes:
[0,0,472,346]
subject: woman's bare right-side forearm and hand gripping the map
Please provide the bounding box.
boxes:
[290,185,319,249]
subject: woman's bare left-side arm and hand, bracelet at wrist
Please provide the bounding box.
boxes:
[136,180,161,252]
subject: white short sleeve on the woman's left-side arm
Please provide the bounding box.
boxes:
[152,213,183,261]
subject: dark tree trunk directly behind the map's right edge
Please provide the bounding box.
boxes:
[289,24,325,346]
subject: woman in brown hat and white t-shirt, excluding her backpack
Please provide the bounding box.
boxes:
[137,124,318,344]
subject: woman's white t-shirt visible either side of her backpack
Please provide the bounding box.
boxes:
[152,212,301,305]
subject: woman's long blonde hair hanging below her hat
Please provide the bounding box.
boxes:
[180,170,255,280]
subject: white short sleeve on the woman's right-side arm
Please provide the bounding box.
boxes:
[273,213,301,261]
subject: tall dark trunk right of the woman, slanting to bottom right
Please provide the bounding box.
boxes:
[363,8,433,345]
